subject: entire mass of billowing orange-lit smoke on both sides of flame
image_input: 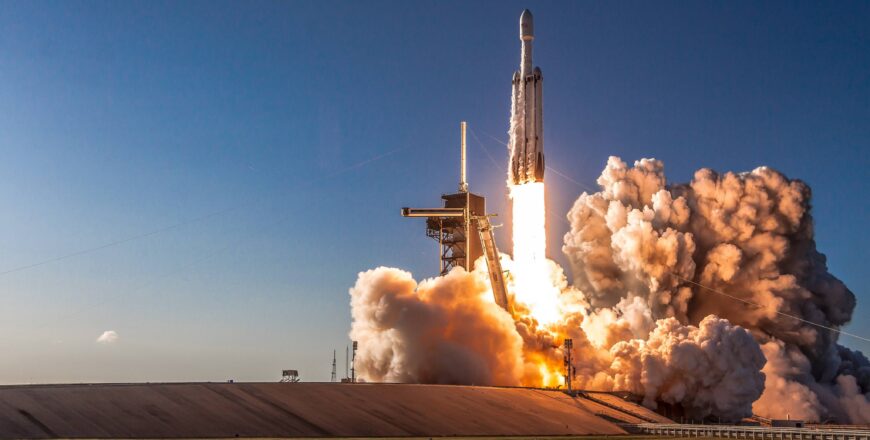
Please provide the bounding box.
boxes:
[350,157,870,423]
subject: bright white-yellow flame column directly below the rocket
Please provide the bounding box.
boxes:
[510,182,560,325]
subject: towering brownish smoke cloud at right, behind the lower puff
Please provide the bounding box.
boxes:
[563,157,870,423]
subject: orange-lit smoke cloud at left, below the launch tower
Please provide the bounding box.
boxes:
[350,267,523,385]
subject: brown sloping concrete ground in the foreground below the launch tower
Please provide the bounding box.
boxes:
[0,383,625,438]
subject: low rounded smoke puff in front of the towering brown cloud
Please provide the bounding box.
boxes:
[610,315,764,420]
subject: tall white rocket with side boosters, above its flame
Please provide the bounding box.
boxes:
[508,9,544,185]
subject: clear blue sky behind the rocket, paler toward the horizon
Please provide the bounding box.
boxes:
[0,1,870,383]
